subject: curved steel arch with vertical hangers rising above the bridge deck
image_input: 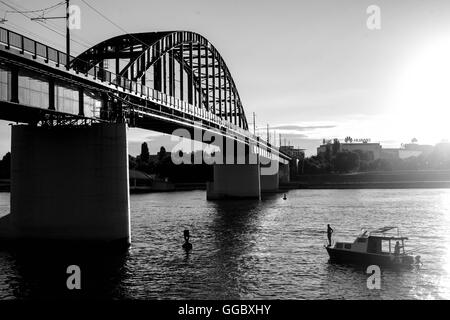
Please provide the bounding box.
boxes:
[71,31,248,130]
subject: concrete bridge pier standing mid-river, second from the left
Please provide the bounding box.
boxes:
[206,164,261,200]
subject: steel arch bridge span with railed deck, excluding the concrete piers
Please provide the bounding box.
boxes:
[0,27,290,163]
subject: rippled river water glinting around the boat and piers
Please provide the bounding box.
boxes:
[0,189,450,299]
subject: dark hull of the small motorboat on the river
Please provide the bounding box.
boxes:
[325,247,414,267]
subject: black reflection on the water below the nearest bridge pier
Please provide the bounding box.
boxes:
[6,248,127,299]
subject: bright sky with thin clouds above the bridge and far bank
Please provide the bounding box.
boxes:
[0,0,450,154]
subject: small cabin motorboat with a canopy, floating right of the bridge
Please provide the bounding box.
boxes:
[325,226,420,267]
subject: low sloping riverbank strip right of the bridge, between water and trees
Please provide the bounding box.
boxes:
[280,170,450,189]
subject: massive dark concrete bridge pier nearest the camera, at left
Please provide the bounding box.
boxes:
[0,124,130,245]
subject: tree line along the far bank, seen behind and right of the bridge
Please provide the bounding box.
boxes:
[0,139,450,182]
